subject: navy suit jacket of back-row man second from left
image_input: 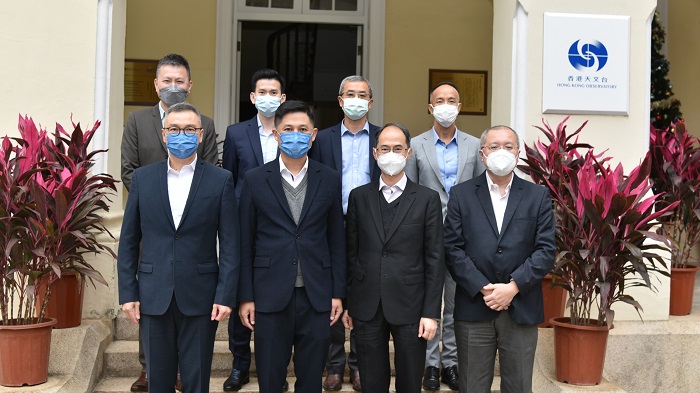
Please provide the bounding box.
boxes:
[222,115,264,200]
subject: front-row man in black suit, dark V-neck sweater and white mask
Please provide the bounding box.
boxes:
[343,123,445,393]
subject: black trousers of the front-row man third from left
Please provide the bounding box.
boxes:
[353,302,427,393]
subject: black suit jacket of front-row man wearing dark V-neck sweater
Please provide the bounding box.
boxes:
[345,180,445,325]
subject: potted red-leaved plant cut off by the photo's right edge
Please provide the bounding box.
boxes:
[649,120,700,315]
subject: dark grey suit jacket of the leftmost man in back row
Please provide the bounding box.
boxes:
[122,104,219,191]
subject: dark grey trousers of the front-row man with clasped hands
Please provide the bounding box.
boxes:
[456,311,537,393]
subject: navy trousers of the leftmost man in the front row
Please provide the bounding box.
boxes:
[140,296,219,393]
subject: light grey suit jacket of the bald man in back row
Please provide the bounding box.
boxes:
[405,129,486,214]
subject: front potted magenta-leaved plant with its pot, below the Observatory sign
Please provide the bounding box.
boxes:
[531,120,676,385]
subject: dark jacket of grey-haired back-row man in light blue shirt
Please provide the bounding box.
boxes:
[309,122,382,182]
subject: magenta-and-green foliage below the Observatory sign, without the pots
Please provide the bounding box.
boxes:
[520,117,676,327]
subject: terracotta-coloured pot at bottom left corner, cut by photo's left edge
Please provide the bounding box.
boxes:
[0,318,56,386]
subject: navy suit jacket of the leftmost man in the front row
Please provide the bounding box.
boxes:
[117,160,240,316]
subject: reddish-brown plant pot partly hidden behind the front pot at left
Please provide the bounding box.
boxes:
[36,272,85,329]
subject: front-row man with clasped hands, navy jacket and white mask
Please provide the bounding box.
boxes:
[445,126,556,393]
